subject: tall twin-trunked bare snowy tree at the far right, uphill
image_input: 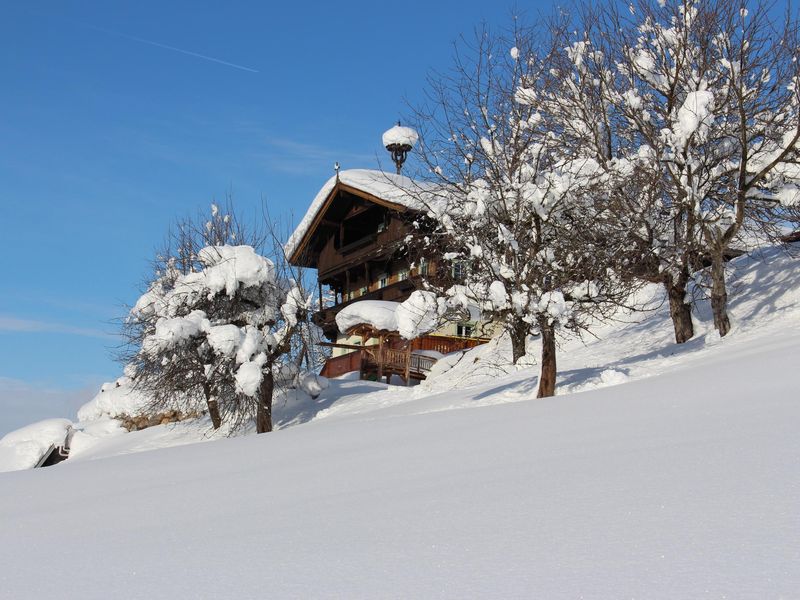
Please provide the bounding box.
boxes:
[554,0,800,342]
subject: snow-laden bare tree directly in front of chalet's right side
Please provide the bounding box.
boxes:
[408,28,626,396]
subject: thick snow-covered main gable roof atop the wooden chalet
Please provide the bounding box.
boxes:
[284,169,425,260]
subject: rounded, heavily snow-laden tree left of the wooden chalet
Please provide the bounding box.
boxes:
[126,207,314,433]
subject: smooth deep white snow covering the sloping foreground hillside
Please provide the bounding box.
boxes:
[0,245,800,599]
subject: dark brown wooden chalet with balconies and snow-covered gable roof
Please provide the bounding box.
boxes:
[286,170,486,384]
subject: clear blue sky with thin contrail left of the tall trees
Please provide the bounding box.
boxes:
[0,0,535,434]
